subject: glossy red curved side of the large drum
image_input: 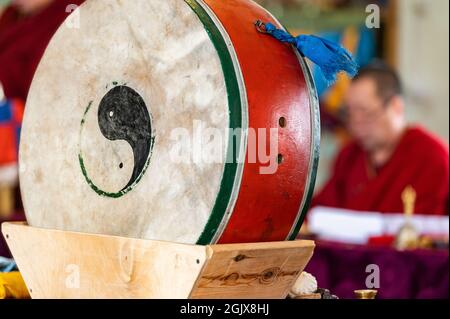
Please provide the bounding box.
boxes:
[197,0,320,243]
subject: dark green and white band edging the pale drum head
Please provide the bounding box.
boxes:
[184,0,248,245]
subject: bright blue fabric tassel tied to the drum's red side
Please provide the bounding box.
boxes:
[265,23,359,85]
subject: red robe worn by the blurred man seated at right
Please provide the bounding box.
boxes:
[313,127,449,215]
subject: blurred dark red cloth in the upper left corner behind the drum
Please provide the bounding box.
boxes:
[0,0,83,101]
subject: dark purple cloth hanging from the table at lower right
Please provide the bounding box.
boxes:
[306,241,449,299]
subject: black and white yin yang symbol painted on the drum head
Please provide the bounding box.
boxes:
[79,85,154,198]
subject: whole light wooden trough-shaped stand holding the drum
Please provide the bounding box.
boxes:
[2,223,314,298]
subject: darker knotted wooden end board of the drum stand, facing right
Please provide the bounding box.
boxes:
[190,241,314,299]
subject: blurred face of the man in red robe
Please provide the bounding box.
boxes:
[345,77,403,152]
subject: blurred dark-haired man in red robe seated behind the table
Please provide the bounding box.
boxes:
[313,63,449,215]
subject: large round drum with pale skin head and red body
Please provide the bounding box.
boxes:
[20,0,319,244]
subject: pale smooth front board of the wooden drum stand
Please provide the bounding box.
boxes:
[2,223,206,298]
